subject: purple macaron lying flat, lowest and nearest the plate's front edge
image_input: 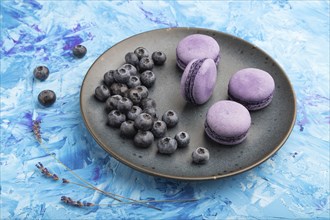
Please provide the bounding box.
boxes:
[204,100,251,145]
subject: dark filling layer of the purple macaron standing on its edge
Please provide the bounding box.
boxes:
[184,58,206,103]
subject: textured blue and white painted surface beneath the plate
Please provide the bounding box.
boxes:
[0,0,330,219]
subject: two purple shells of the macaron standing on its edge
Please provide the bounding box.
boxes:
[180,59,217,105]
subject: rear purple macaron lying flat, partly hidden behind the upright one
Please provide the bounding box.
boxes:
[176,34,220,70]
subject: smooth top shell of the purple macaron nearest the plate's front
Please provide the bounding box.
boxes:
[206,100,251,138]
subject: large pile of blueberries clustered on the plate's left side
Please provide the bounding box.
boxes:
[95,47,190,154]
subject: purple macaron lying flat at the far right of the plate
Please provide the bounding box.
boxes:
[228,68,275,111]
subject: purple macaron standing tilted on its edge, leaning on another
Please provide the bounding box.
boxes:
[180,58,217,105]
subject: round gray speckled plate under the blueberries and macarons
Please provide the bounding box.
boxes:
[80,28,296,180]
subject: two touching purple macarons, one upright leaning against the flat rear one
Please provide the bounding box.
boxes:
[176,34,220,105]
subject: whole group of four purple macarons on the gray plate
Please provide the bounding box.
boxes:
[176,34,275,145]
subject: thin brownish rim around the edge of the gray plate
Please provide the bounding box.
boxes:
[79,27,297,181]
